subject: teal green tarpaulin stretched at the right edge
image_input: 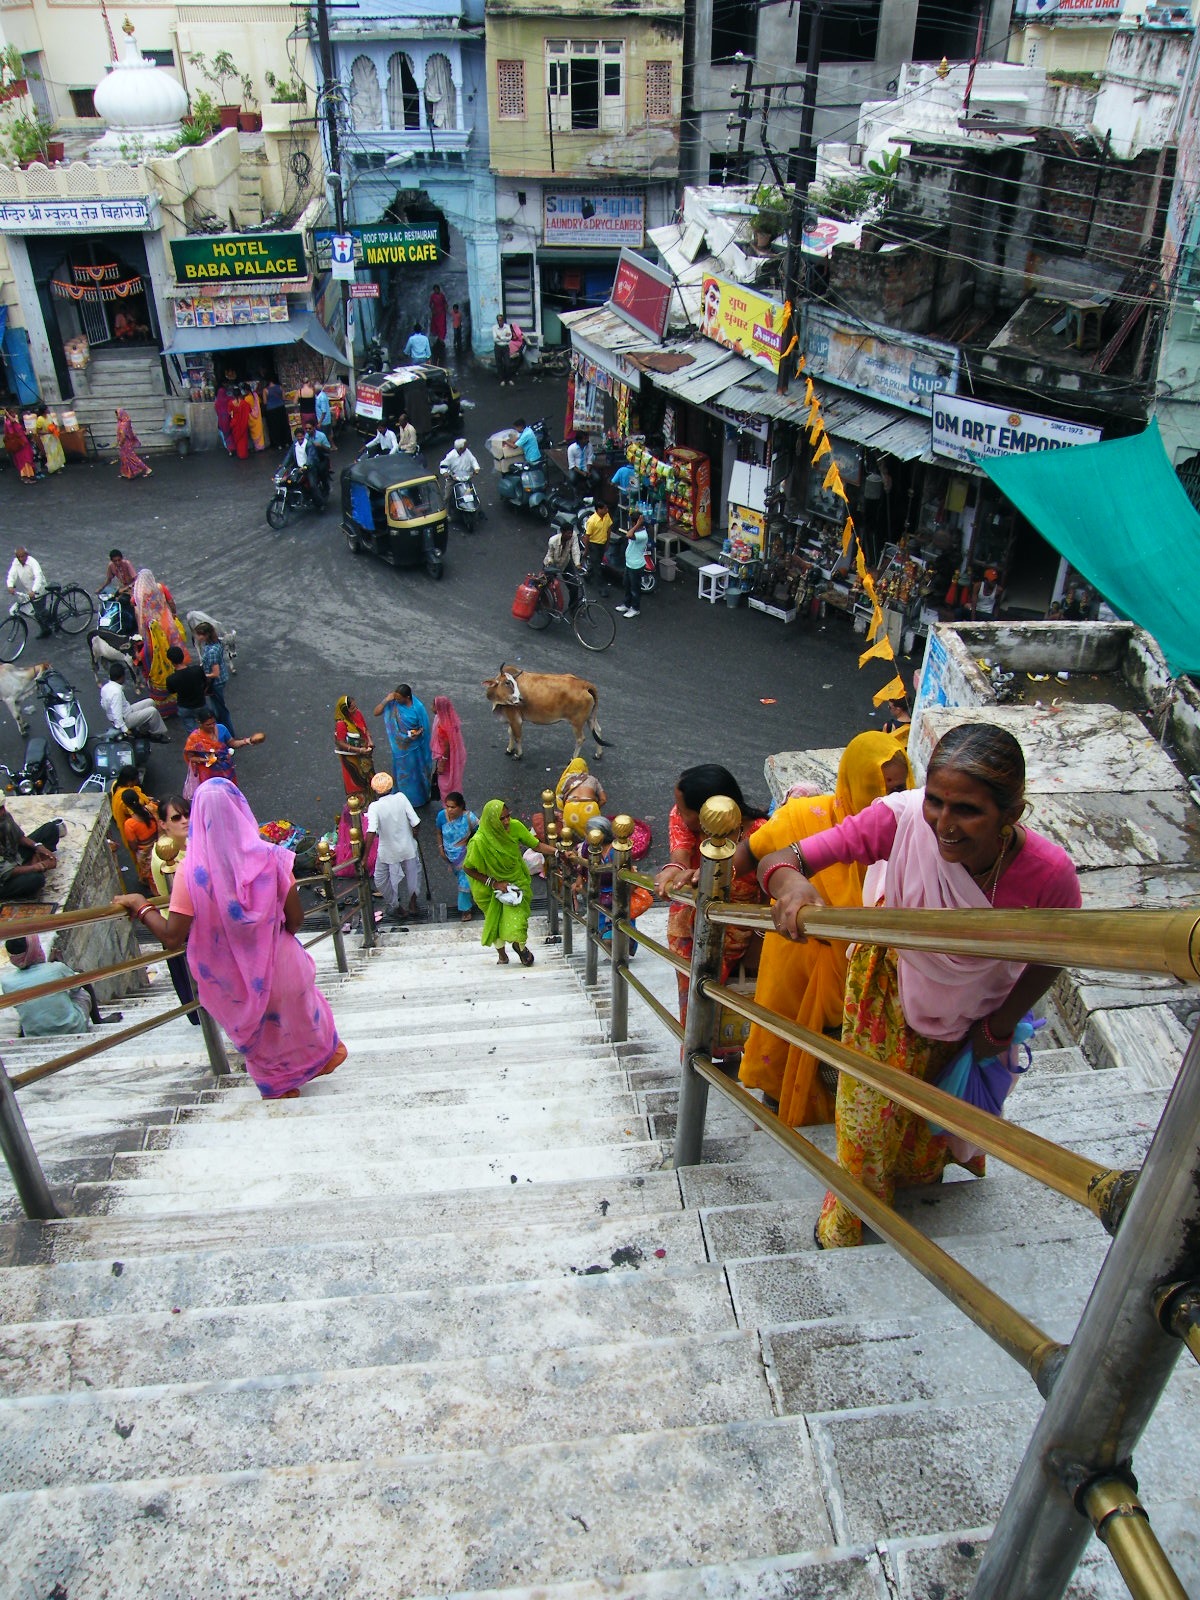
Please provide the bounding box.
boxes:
[979,422,1200,674]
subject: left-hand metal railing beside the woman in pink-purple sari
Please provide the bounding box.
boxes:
[0,812,374,1221]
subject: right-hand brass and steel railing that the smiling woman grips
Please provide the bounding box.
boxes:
[542,790,1200,1600]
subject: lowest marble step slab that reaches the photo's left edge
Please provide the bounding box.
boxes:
[0,1419,830,1600]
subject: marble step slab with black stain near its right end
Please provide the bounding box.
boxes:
[0,1210,709,1323]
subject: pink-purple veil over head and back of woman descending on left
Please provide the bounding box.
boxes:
[179,778,294,1054]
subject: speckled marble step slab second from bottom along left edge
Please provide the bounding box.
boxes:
[0,1333,773,1494]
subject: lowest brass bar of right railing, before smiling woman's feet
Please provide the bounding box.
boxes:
[691,1056,1064,1394]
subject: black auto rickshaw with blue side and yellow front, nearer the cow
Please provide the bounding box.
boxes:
[342,454,450,578]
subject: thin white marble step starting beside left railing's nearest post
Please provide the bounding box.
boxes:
[75,1126,664,1214]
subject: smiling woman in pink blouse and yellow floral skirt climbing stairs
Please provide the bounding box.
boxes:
[758,723,1080,1250]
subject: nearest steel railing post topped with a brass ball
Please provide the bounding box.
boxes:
[674,795,742,1166]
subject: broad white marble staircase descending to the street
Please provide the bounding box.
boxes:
[0,910,1200,1600]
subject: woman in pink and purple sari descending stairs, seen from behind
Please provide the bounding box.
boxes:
[117,778,346,1099]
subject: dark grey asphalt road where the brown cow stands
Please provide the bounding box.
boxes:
[0,366,878,893]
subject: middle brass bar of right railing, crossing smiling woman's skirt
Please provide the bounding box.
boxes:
[702,979,1128,1227]
